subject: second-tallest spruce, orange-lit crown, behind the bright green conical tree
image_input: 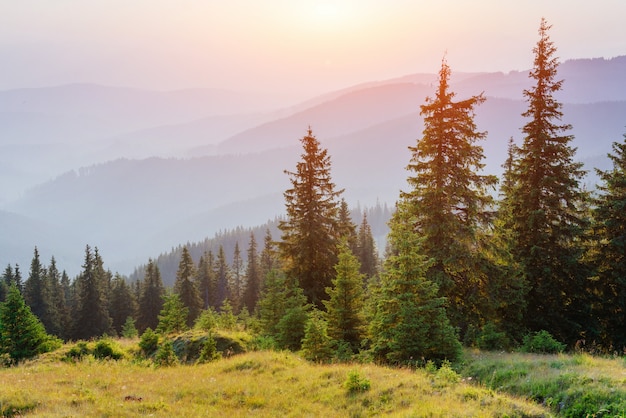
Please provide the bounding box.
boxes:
[400,60,497,333]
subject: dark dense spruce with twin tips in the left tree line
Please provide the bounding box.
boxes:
[72,245,111,340]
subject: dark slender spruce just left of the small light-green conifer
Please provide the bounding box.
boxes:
[137,259,165,333]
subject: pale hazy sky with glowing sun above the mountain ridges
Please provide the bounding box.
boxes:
[0,0,626,100]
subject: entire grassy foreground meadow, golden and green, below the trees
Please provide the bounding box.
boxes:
[0,331,626,417]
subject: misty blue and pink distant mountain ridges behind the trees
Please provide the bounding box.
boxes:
[0,56,626,273]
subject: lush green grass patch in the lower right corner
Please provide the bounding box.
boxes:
[462,351,626,417]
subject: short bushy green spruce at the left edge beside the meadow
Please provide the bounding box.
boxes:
[0,285,52,363]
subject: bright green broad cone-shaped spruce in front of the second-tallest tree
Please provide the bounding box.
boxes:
[369,202,461,364]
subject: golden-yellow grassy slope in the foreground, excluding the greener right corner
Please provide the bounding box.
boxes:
[0,352,548,417]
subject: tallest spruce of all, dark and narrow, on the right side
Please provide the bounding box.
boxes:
[507,19,593,343]
